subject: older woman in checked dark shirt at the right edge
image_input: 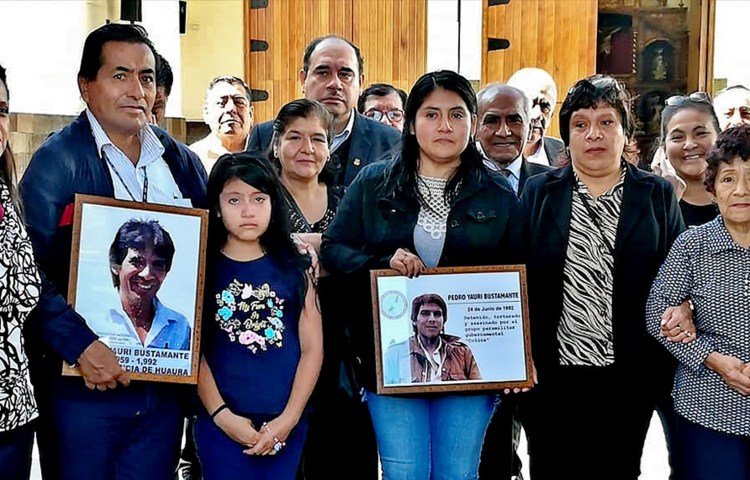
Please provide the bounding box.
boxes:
[646,125,750,480]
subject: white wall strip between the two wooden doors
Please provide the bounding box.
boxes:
[427,0,482,80]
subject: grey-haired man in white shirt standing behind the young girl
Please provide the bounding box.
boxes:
[190,76,253,172]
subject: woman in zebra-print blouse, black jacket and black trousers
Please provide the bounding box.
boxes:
[521,75,684,480]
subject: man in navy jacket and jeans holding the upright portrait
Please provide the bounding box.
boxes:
[20,24,207,480]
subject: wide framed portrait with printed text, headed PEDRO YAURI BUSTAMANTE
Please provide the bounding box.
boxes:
[370,265,533,395]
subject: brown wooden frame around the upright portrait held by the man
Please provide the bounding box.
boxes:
[63,194,208,384]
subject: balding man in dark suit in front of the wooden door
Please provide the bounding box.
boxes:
[248,35,399,186]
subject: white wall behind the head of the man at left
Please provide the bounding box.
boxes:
[0,0,182,116]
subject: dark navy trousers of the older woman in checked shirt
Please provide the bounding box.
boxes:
[674,414,750,480]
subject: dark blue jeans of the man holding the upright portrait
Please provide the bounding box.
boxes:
[50,379,183,480]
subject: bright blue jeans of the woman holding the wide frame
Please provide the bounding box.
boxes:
[367,392,499,480]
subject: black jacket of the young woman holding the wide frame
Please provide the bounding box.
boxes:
[320,158,523,388]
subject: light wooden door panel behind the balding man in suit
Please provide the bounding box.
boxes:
[250,0,427,122]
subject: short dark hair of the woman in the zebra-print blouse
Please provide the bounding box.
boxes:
[560,74,635,147]
